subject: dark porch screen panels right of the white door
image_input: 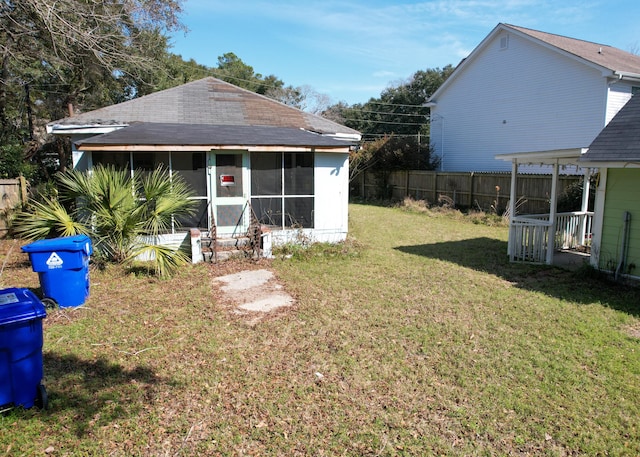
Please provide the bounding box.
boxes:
[251,152,314,228]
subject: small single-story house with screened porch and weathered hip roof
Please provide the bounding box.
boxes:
[47,77,361,258]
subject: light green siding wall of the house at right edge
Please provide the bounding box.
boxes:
[598,168,640,277]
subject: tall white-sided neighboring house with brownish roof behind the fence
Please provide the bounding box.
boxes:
[427,24,640,173]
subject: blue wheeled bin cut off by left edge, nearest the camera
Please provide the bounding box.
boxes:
[0,288,47,409]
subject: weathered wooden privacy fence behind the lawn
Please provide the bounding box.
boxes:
[351,170,582,214]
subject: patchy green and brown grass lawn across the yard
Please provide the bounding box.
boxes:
[0,205,640,456]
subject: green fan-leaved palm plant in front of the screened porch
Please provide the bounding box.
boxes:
[13,166,193,276]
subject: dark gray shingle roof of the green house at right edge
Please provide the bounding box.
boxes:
[580,95,640,162]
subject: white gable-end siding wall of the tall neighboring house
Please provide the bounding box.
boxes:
[431,32,607,171]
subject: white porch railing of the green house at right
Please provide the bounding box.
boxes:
[509,211,593,263]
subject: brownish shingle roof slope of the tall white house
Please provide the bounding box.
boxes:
[502,24,640,74]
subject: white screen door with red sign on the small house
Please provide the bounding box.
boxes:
[209,151,249,236]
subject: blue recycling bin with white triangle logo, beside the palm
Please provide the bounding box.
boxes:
[22,235,93,308]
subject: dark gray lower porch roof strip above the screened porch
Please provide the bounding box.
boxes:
[76,123,350,148]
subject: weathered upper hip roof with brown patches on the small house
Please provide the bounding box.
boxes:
[48,77,359,136]
